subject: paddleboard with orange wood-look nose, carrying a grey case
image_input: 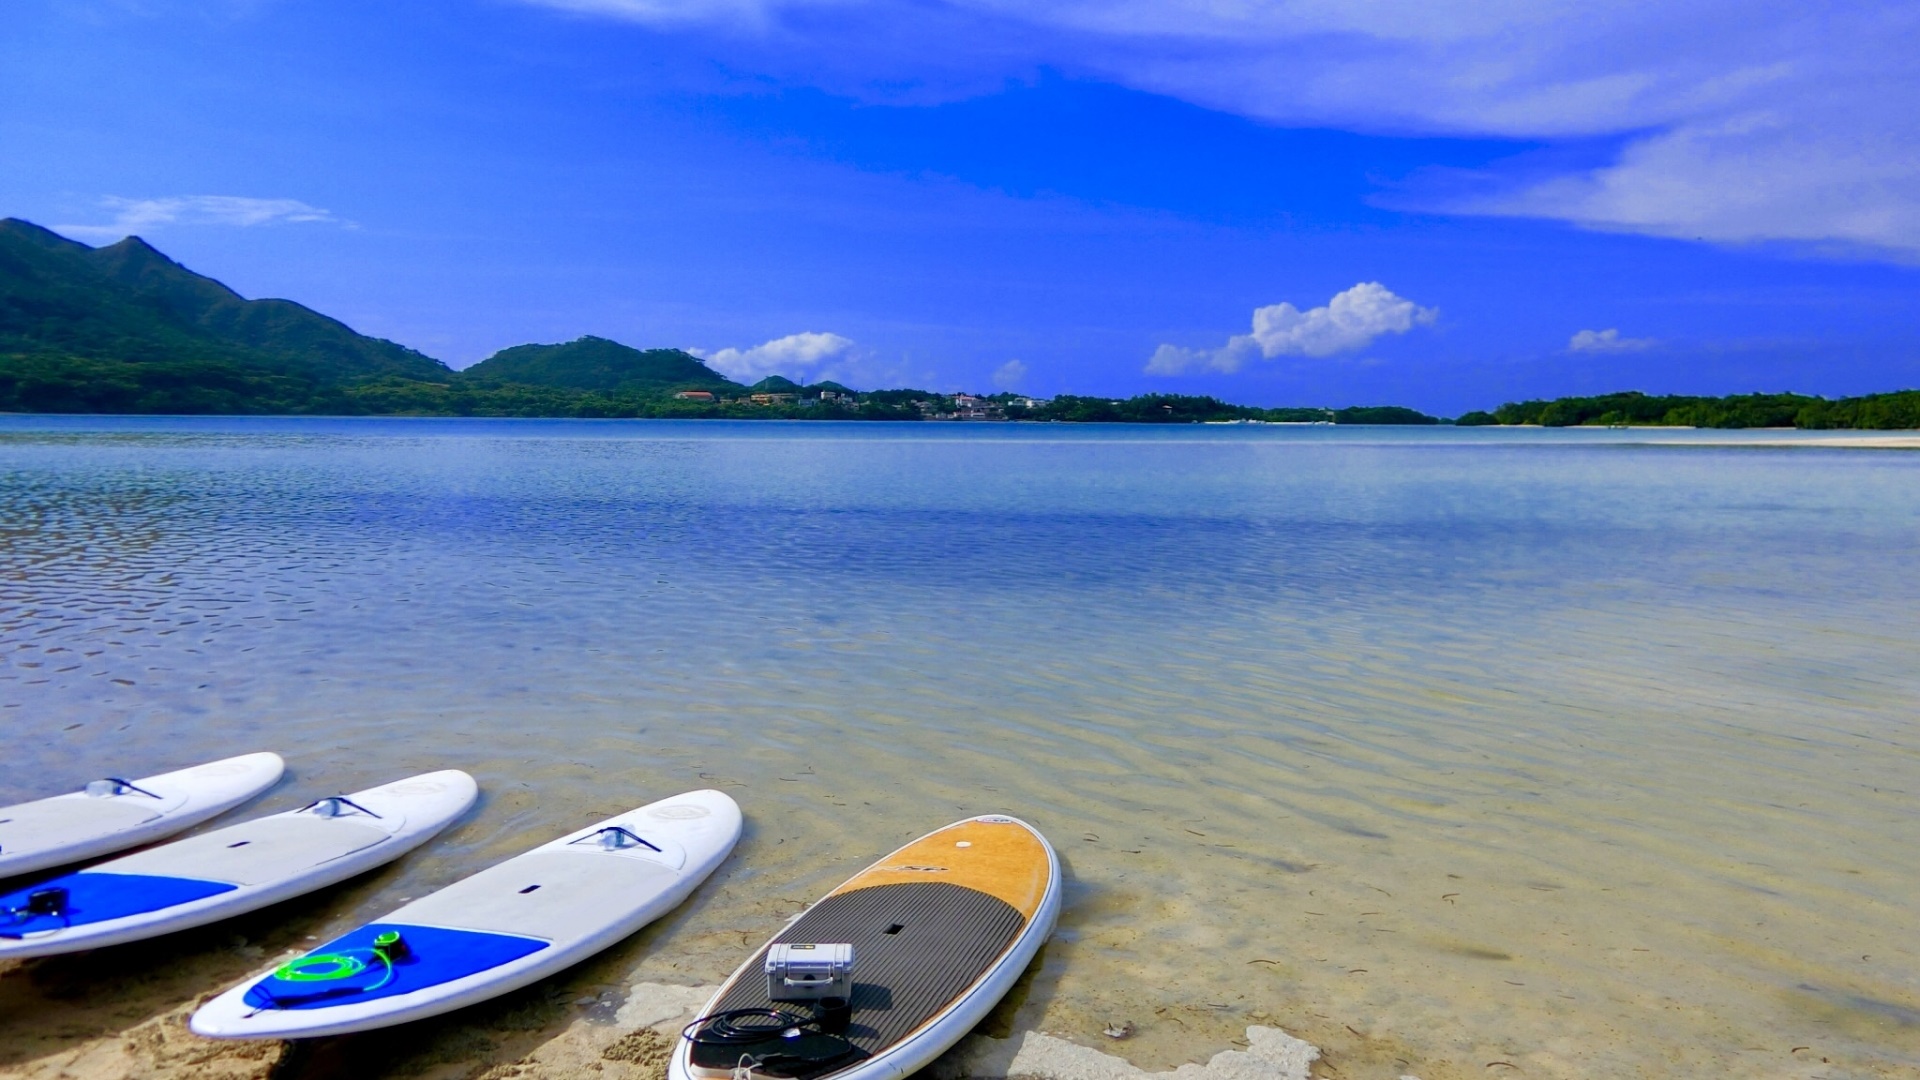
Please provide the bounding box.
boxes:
[668,815,1060,1080]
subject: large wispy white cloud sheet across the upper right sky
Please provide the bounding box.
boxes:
[528,0,1920,258]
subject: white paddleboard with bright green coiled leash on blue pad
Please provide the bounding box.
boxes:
[192,792,741,1038]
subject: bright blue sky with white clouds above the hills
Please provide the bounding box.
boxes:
[0,0,1920,413]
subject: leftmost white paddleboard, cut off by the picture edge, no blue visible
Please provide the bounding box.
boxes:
[0,753,286,878]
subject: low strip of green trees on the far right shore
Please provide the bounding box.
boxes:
[1453,390,1920,430]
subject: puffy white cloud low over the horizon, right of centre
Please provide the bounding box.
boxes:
[1146,281,1440,375]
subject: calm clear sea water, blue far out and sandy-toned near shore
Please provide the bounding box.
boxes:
[0,417,1920,1080]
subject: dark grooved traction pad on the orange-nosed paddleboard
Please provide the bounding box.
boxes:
[693,882,1027,1068]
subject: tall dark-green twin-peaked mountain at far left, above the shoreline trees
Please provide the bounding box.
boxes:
[0,217,451,384]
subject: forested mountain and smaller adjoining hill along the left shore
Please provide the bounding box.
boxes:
[0,219,745,415]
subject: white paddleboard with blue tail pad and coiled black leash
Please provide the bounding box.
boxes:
[0,769,480,959]
